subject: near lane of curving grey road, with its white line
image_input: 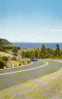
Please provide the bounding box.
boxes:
[0,60,62,91]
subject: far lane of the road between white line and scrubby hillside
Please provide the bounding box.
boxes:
[0,60,45,75]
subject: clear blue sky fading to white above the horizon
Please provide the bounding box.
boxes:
[0,0,62,42]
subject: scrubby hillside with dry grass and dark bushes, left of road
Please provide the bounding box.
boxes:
[0,39,31,69]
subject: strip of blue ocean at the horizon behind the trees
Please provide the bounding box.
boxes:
[15,43,62,49]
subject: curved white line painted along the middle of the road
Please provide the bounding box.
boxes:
[0,62,48,76]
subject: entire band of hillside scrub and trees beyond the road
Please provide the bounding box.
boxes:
[0,39,62,69]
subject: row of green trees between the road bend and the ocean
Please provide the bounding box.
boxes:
[21,44,62,59]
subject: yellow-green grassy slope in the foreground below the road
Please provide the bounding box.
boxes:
[0,69,62,99]
